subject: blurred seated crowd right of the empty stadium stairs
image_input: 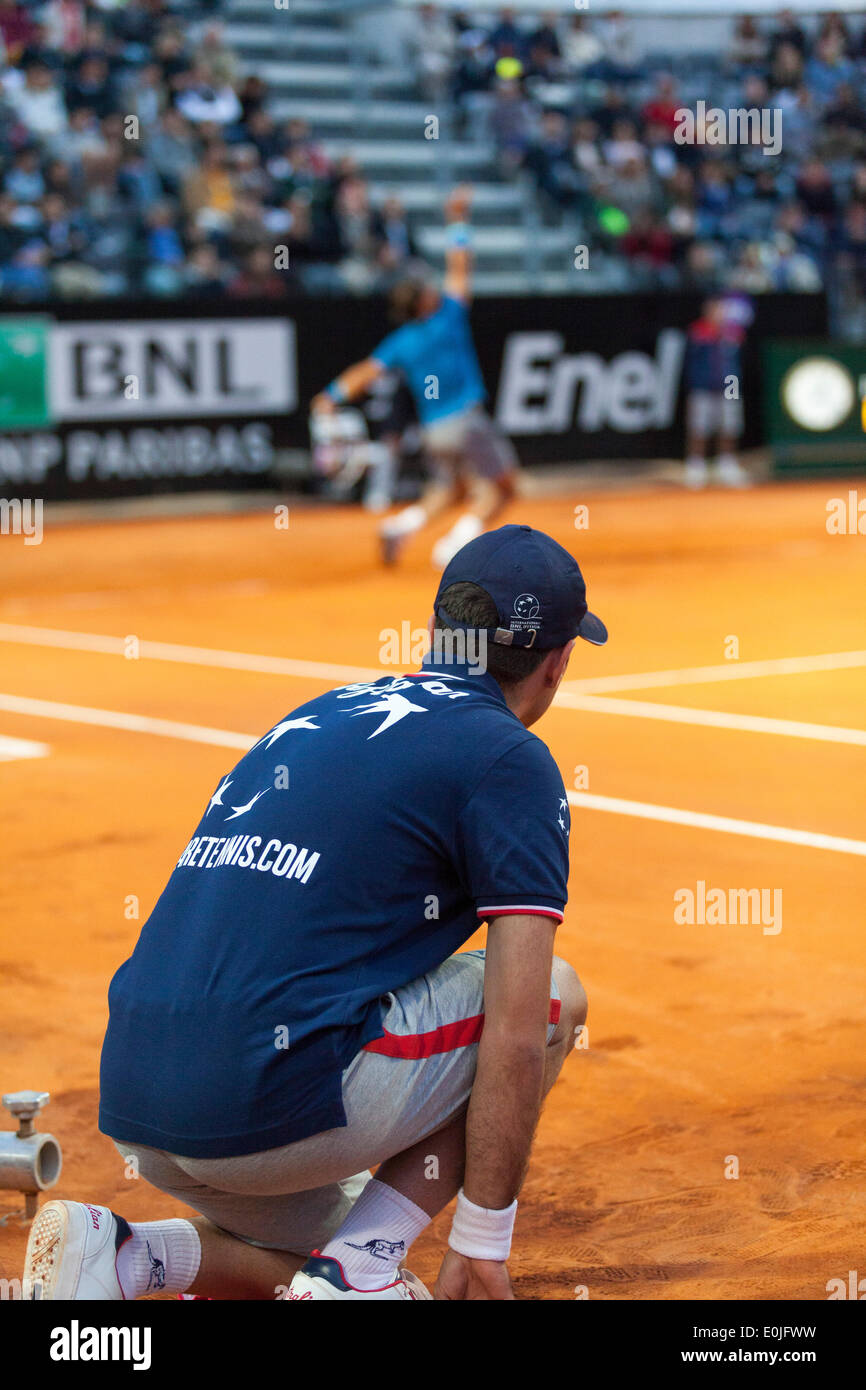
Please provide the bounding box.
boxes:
[433,6,866,314]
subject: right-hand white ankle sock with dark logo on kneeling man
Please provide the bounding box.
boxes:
[322,1177,431,1289]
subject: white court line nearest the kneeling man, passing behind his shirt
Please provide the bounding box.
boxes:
[0,695,866,855]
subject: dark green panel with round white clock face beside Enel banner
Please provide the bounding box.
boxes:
[763,341,866,473]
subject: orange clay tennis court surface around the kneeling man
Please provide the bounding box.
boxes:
[0,482,866,1301]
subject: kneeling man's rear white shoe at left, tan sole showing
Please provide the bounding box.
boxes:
[22,1201,132,1302]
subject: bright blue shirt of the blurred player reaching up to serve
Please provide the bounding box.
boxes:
[370,295,487,425]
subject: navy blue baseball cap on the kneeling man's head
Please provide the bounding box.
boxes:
[434,525,607,651]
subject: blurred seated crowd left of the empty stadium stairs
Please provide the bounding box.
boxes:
[0,0,414,302]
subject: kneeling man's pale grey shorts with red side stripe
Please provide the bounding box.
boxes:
[115,951,562,1255]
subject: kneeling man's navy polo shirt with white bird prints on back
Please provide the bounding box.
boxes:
[100,663,569,1158]
